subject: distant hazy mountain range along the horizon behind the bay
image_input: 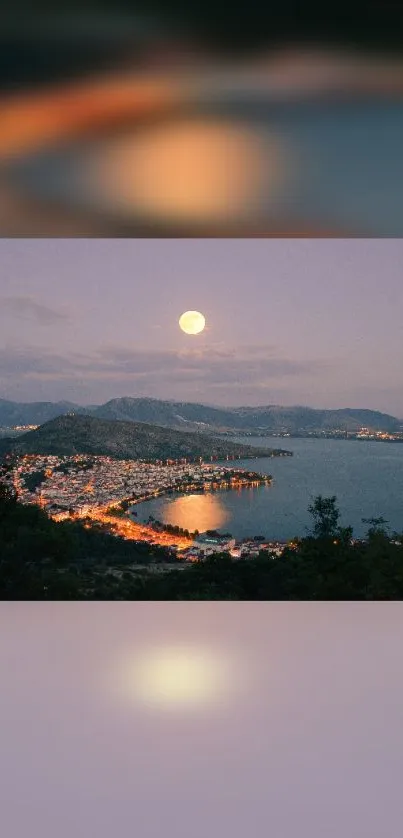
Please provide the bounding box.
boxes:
[0,397,403,434]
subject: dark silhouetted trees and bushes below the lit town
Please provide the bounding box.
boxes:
[0,472,403,600]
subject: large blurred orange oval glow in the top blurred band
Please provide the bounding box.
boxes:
[89,119,286,223]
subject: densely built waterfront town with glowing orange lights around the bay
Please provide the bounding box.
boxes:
[3,454,286,561]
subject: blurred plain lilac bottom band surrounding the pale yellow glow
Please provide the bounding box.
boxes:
[0,602,403,838]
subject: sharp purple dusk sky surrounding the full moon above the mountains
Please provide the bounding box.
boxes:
[0,239,403,417]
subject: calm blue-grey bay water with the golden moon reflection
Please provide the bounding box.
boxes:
[136,437,403,541]
